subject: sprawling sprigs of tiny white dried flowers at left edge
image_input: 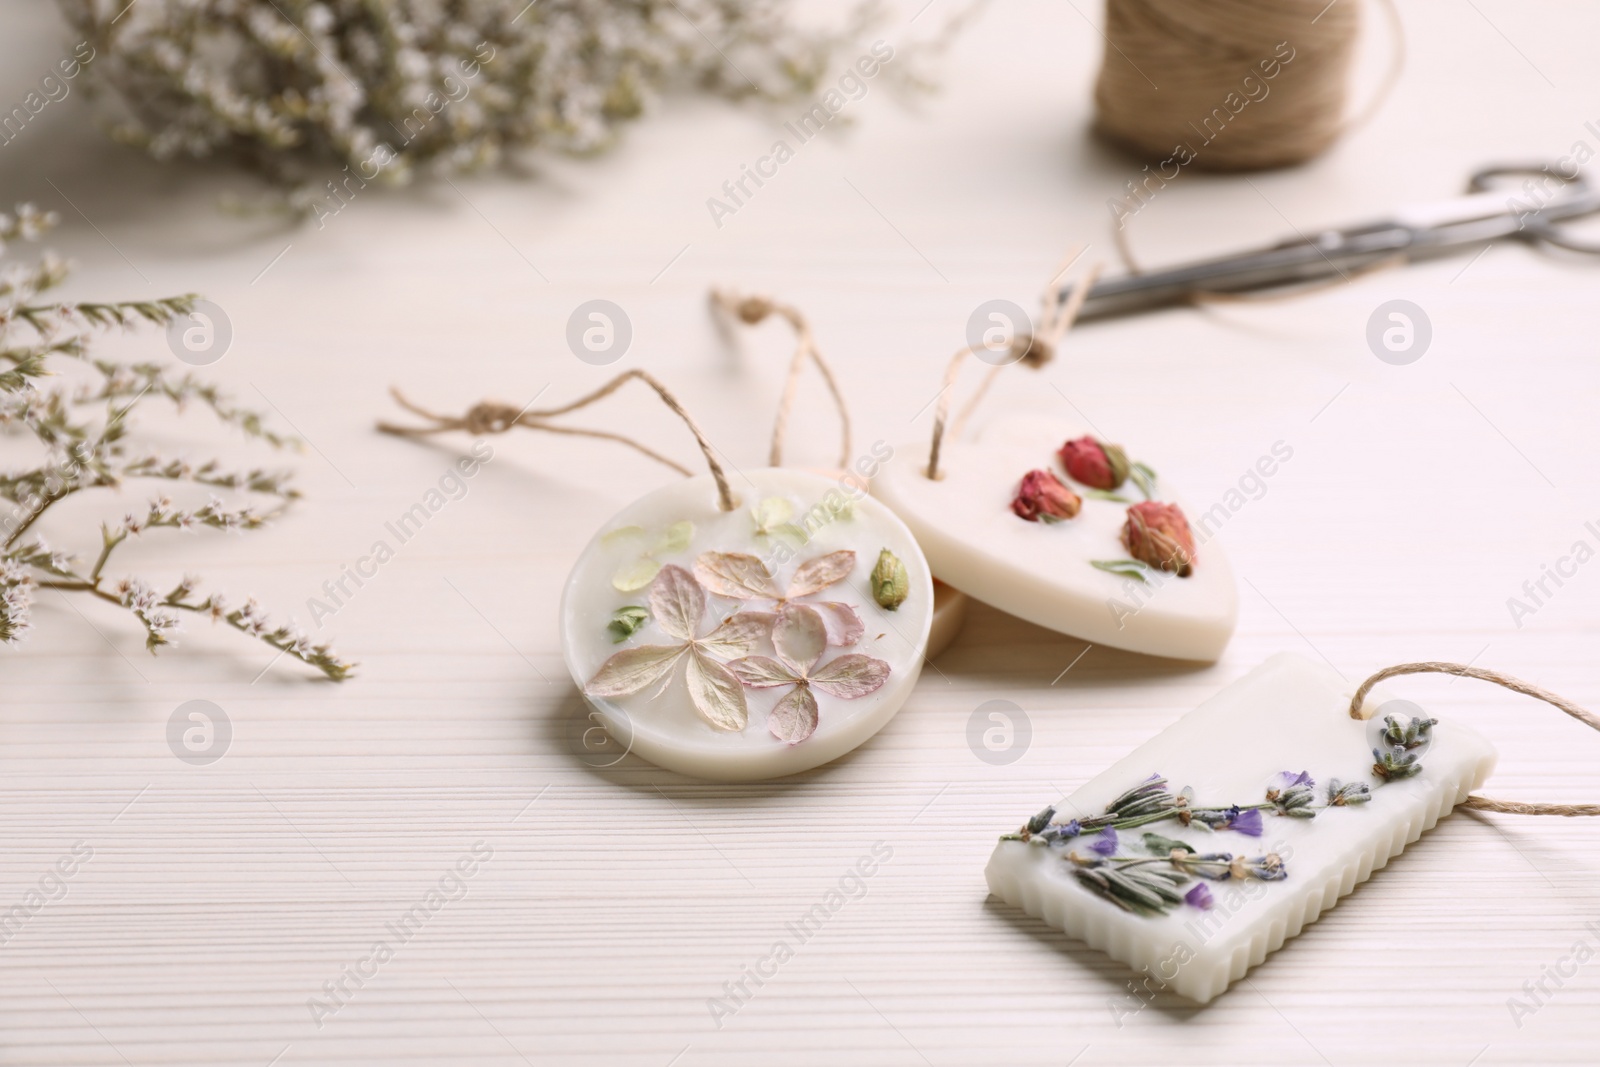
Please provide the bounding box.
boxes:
[0,205,354,681]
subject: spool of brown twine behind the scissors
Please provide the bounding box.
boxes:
[1094,0,1362,170]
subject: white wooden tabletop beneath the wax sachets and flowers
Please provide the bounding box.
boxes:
[0,0,1600,1067]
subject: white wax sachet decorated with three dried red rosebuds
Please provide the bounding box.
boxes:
[872,427,1238,661]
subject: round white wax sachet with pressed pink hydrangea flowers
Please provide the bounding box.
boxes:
[562,469,934,781]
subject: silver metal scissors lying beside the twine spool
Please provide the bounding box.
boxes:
[1059,163,1600,322]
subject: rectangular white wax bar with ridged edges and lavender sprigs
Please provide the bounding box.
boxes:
[986,653,1494,1003]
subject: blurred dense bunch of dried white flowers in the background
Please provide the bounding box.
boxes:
[59,0,880,179]
